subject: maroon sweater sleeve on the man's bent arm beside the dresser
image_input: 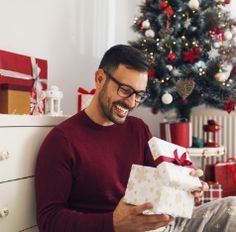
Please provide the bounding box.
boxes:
[35,129,114,232]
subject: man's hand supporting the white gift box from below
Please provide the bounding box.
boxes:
[113,199,173,232]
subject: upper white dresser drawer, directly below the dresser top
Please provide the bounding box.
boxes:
[0,127,52,182]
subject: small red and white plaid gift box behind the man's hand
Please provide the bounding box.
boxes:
[201,182,222,204]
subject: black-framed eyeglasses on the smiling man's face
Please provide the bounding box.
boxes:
[103,69,149,103]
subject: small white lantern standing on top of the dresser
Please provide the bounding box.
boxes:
[45,85,63,116]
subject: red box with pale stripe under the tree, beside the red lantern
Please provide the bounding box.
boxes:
[160,122,192,147]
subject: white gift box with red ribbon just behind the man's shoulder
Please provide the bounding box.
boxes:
[78,87,96,112]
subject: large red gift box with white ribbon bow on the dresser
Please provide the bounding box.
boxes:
[0,50,47,113]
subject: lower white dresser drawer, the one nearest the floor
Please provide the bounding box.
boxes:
[0,178,36,232]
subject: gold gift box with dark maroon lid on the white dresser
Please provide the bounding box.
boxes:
[0,84,31,114]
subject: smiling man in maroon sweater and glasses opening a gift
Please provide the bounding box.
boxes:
[36,45,236,232]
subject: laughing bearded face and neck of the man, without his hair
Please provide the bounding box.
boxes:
[85,64,148,126]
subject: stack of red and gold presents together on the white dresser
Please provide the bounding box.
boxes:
[0,50,47,114]
